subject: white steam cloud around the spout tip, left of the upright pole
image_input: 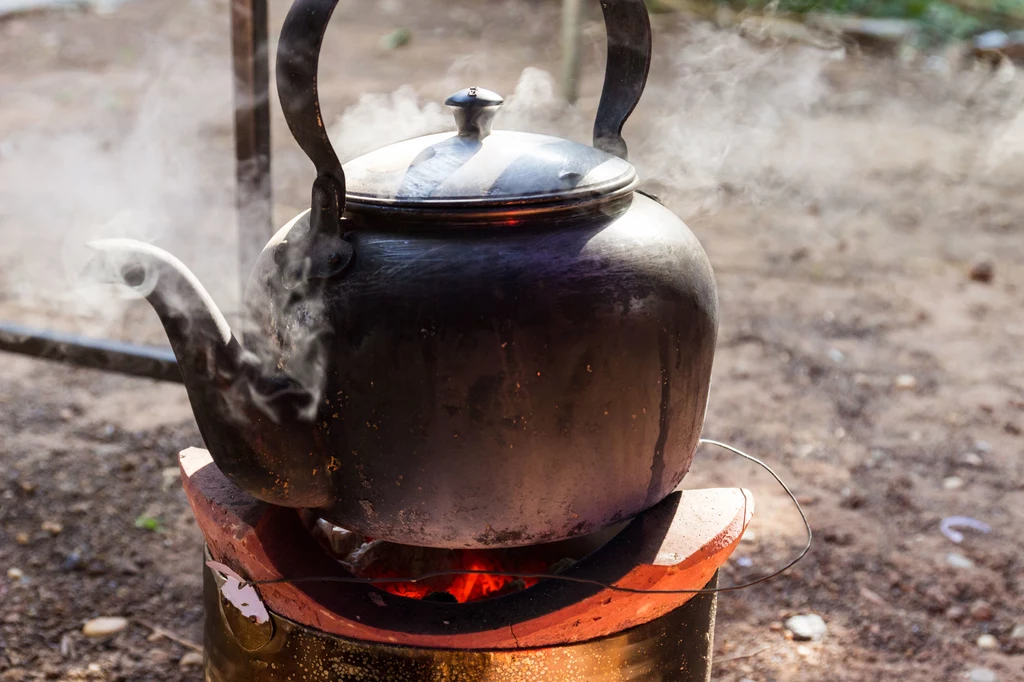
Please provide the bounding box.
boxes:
[0,38,237,343]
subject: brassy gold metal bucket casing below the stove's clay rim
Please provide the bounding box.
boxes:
[203,566,718,682]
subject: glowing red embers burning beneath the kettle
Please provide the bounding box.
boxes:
[378,550,548,603]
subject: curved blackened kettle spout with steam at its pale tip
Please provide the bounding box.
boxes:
[83,239,331,507]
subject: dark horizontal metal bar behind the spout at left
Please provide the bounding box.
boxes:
[0,322,181,383]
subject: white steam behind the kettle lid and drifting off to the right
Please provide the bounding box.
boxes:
[330,24,1024,219]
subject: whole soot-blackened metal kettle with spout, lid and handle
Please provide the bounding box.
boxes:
[93,0,718,548]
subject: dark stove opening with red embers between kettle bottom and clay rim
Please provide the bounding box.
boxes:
[305,514,626,603]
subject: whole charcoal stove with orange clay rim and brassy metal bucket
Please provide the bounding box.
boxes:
[180,449,754,682]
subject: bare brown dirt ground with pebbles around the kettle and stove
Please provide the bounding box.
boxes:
[0,0,1024,682]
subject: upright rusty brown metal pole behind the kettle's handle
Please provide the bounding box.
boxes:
[231,0,273,291]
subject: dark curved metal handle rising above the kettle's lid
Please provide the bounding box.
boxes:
[278,0,651,209]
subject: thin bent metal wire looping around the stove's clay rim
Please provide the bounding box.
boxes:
[241,438,814,594]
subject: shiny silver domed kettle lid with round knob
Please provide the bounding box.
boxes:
[344,87,637,219]
